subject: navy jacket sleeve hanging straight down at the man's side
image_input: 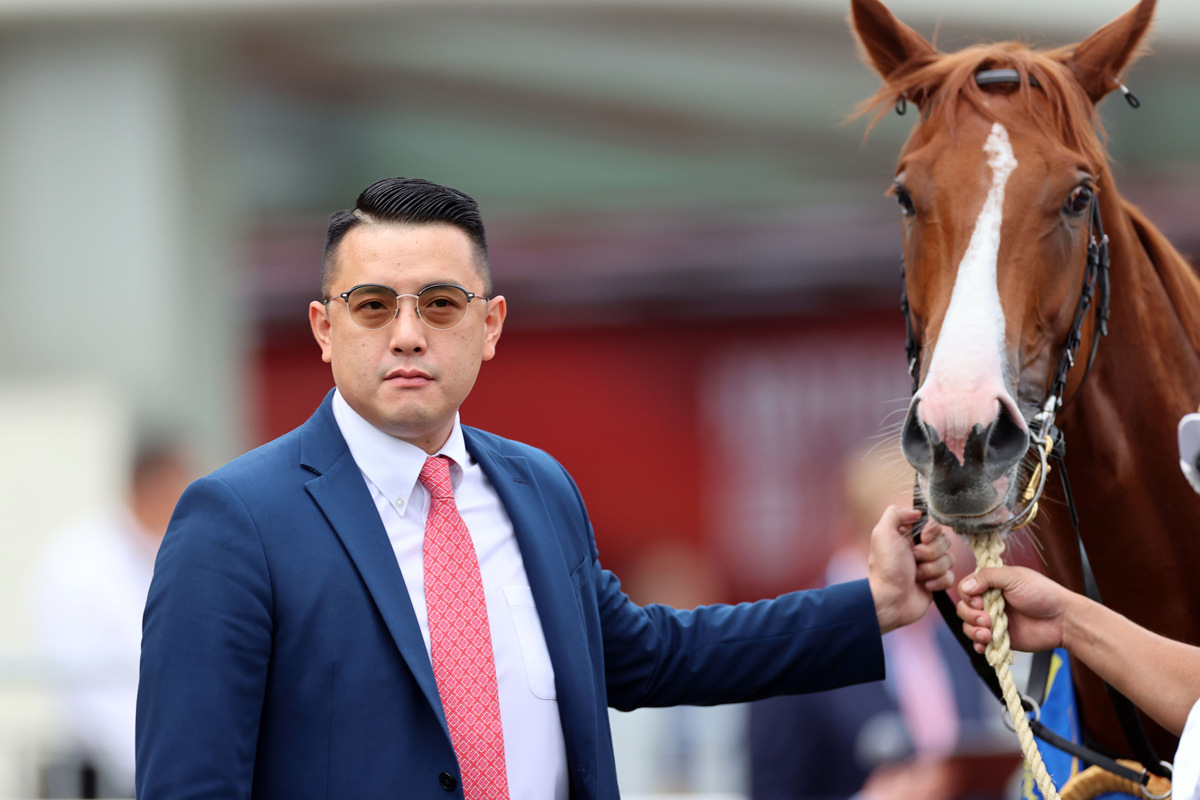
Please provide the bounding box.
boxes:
[137,477,272,800]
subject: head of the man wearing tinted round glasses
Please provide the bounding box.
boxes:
[308,178,506,452]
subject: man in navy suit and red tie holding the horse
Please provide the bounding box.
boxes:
[138,179,953,800]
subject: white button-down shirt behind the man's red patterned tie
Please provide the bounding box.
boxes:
[334,392,568,800]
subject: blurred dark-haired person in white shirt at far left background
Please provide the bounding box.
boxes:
[30,439,193,798]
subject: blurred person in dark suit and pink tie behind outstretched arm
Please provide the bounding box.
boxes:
[750,447,995,800]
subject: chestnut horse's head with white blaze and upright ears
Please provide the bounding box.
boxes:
[851,0,1154,534]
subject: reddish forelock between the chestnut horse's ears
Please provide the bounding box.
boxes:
[853,42,1108,170]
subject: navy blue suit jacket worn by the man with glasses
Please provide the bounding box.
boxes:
[137,397,883,800]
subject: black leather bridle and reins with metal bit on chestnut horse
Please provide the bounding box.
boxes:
[898,70,1170,790]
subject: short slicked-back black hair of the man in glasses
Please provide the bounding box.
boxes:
[320,178,492,300]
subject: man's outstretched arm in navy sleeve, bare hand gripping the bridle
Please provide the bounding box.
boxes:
[593,507,954,709]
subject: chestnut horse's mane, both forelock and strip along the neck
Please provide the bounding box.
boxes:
[852,42,1200,353]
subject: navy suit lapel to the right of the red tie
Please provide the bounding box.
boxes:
[463,427,598,771]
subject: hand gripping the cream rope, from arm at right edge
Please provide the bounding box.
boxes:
[958,566,1078,652]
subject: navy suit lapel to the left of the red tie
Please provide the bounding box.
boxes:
[301,397,450,736]
